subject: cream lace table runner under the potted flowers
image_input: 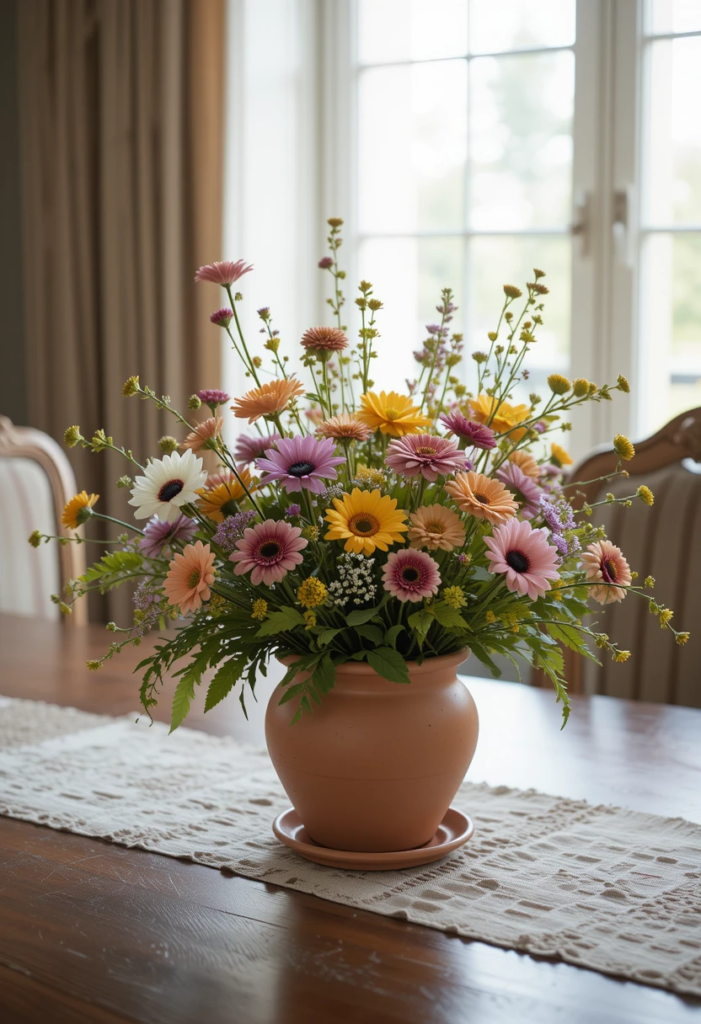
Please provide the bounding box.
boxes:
[0,698,701,996]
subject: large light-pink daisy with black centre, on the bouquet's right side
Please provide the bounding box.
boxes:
[484,519,560,601]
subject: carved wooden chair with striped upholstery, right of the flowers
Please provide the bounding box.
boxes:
[566,408,701,708]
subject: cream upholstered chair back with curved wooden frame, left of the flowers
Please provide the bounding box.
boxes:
[0,416,87,625]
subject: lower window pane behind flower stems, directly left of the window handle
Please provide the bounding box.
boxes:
[466,236,571,400]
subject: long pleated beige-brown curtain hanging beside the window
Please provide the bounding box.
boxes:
[18,0,224,616]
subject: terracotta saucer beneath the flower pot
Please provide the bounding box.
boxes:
[272,807,475,871]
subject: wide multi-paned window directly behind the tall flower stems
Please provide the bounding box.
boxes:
[355,0,575,411]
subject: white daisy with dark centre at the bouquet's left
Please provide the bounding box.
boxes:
[129,449,207,522]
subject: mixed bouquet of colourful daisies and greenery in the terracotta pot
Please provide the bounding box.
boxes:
[30,218,689,728]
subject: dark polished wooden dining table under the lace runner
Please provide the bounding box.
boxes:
[0,614,701,1024]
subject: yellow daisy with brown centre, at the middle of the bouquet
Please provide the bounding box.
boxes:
[324,487,408,555]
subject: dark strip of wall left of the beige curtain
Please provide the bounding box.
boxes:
[0,0,29,424]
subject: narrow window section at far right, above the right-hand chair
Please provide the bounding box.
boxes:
[639,0,701,433]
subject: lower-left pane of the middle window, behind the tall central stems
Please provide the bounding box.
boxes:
[358,239,464,391]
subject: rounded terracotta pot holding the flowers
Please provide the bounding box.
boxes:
[265,651,479,853]
